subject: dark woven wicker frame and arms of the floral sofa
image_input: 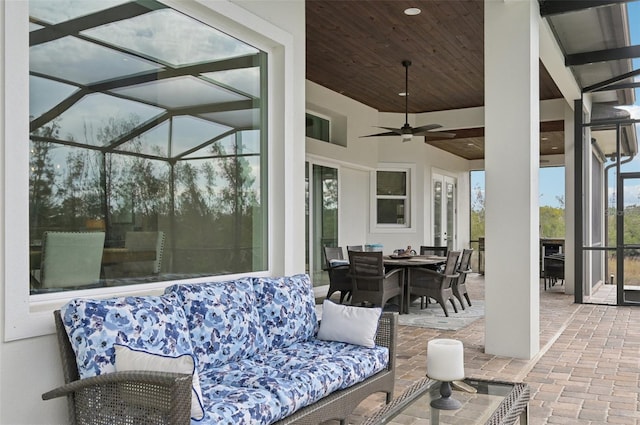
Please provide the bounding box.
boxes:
[42,310,398,425]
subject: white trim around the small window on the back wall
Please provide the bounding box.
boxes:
[369,162,417,233]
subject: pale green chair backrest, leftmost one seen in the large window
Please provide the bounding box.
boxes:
[40,232,105,288]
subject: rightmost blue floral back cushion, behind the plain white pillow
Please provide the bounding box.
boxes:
[254,274,318,349]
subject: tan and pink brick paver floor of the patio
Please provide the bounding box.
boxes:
[327,275,640,425]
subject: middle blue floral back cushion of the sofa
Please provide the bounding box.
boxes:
[165,278,266,370]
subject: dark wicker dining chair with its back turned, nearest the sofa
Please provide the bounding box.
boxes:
[349,251,404,313]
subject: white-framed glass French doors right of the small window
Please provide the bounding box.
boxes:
[431,174,456,250]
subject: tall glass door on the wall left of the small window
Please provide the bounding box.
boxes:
[306,164,338,286]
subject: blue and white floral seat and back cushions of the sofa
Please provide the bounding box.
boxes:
[62,275,389,425]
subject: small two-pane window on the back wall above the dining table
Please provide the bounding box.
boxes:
[376,170,410,227]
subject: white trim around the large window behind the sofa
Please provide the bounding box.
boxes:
[0,0,293,341]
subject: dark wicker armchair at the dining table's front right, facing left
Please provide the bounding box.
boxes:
[407,251,460,317]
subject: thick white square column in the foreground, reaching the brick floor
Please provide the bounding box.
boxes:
[484,0,540,359]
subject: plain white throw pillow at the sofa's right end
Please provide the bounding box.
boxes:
[318,300,382,348]
